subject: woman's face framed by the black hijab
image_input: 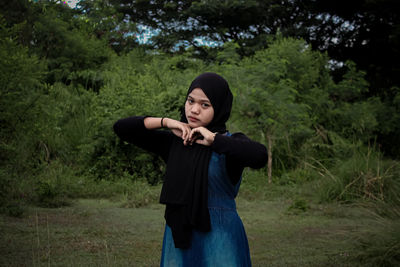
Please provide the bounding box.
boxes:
[185,88,214,128]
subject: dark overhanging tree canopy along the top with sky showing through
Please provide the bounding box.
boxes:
[101,0,400,103]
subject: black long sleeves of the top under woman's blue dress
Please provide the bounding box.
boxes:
[114,117,268,184]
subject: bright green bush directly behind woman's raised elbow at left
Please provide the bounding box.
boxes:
[81,50,205,184]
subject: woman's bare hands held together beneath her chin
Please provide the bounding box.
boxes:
[164,119,215,146]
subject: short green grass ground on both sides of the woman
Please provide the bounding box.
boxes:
[0,191,368,266]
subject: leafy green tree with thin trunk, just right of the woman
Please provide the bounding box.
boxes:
[231,38,324,182]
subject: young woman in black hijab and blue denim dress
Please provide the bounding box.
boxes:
[114,73,267,267]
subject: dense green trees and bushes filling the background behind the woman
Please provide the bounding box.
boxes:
[0,0,400,266]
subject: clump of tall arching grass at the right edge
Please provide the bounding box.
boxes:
[308,147,400,204]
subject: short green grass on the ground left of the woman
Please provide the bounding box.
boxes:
[0,199,163,266]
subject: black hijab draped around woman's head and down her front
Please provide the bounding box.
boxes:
[160,72,233,248]
